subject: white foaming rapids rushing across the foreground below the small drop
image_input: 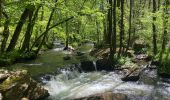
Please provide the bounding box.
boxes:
[43,70,170,100]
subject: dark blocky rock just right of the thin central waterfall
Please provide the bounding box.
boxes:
[96,59,114,71]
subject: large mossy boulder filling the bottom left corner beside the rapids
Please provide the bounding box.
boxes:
[0,70,49,100]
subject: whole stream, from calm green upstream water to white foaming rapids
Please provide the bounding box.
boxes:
[9,39,170,100]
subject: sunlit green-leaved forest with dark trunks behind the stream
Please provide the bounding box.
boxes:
[0,0,170,72]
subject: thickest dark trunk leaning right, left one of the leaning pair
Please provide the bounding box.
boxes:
[7,8,30,51]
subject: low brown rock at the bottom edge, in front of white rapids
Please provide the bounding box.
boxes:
[74,92,129,100]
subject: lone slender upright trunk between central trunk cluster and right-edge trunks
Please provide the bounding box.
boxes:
[152,0,157,55]
